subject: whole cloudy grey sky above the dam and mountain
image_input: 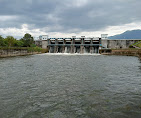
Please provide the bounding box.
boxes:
[0,0,141,38]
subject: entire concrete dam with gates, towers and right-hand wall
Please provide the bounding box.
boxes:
[35,35,141,54]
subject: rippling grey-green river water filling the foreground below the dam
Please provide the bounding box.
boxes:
[0,54,141,118]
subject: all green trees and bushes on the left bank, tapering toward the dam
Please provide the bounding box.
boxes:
[0,33,47,53]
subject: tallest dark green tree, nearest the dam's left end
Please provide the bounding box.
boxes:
[21,33,34,47]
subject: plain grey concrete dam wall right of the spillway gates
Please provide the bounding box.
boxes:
[101,39,141,49]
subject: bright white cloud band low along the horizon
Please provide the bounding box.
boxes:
[0,22,141,38]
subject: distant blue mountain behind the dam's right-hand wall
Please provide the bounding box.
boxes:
[108,30,141,39]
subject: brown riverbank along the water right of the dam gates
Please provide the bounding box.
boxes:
[100,48,141,59]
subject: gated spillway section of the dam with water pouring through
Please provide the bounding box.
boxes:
[36,36,101,54]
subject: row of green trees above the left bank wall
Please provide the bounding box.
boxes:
[0,33,35,47]
